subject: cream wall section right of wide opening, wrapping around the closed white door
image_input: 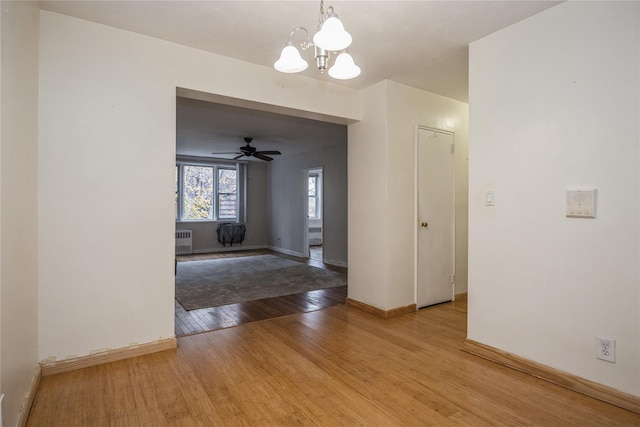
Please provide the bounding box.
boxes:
[349,81,468,310]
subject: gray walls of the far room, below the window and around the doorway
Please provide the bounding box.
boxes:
[176,142,347,266]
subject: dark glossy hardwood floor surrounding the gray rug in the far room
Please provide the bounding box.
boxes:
[175,249,347,337]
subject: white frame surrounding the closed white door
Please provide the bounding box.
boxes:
[413,124,456,307]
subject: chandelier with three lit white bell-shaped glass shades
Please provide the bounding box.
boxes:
[273,0,360,80]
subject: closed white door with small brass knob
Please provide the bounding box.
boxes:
[416,128,455,307]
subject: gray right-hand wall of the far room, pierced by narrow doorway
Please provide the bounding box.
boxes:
[269,142,347,267]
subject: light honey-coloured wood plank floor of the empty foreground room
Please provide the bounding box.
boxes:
[28,301,640,427]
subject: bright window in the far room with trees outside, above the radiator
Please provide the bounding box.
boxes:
[176,161,244,221]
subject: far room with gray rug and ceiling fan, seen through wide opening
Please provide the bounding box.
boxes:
[175,95,347,337]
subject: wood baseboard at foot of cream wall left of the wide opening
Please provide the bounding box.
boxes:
[42,337,178,377]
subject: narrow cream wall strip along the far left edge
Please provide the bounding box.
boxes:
[0,2,39,426]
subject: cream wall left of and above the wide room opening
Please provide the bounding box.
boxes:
[38,11,359,359]
